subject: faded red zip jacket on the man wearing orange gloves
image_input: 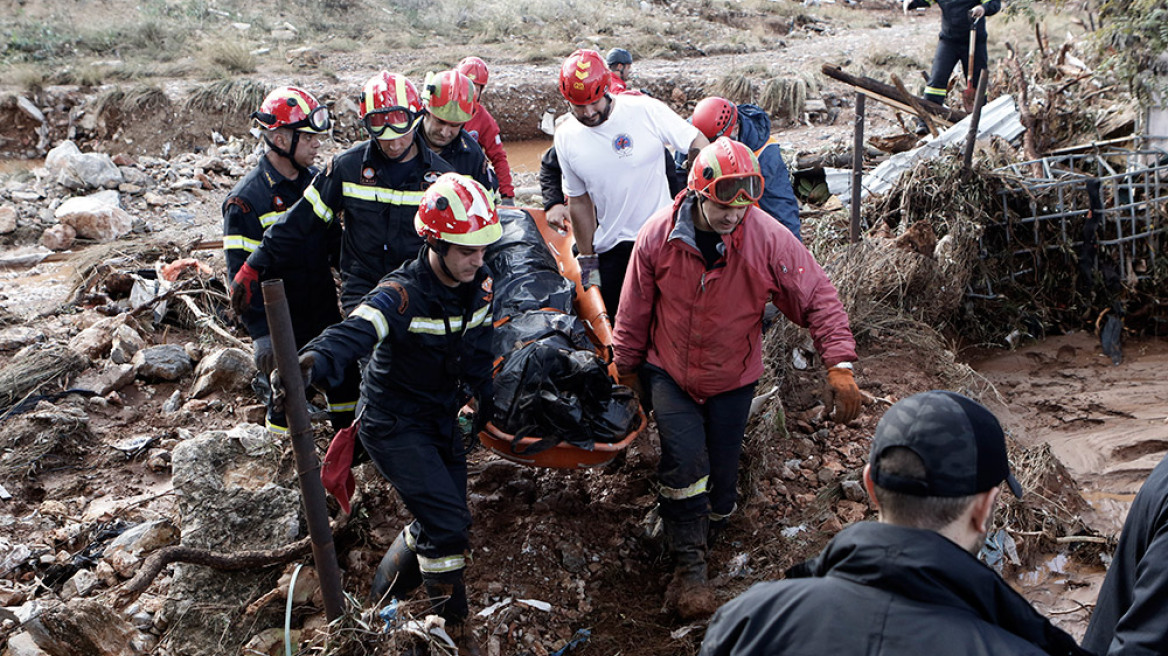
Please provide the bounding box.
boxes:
[614,194,856,403]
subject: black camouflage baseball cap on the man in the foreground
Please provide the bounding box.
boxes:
[868,391,1022,498]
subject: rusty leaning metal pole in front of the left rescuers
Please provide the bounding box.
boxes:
[262,280,345,621]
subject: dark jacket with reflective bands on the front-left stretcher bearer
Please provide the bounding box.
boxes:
[303,249,494,419]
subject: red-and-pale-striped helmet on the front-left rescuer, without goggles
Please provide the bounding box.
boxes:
[413,173,503,246]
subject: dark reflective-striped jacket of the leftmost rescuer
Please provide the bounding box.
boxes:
[223,156,341,344]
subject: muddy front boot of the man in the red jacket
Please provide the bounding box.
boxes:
[665,517,717,622]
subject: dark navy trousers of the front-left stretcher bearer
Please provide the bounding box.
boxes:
[357,403,471,567]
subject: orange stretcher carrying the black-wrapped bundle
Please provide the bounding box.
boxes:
[479,208,648,469]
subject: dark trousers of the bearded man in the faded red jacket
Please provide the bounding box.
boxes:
[641,364,756,522]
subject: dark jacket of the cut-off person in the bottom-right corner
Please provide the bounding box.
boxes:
[1083,458,1168,656]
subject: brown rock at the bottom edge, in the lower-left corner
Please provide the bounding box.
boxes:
[25,599,137,656]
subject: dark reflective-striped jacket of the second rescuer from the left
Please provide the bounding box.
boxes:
[248,130,453,310]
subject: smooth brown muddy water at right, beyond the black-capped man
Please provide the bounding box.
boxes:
[971,333,1168,637]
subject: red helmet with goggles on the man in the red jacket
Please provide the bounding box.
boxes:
[689,137,763,207]
